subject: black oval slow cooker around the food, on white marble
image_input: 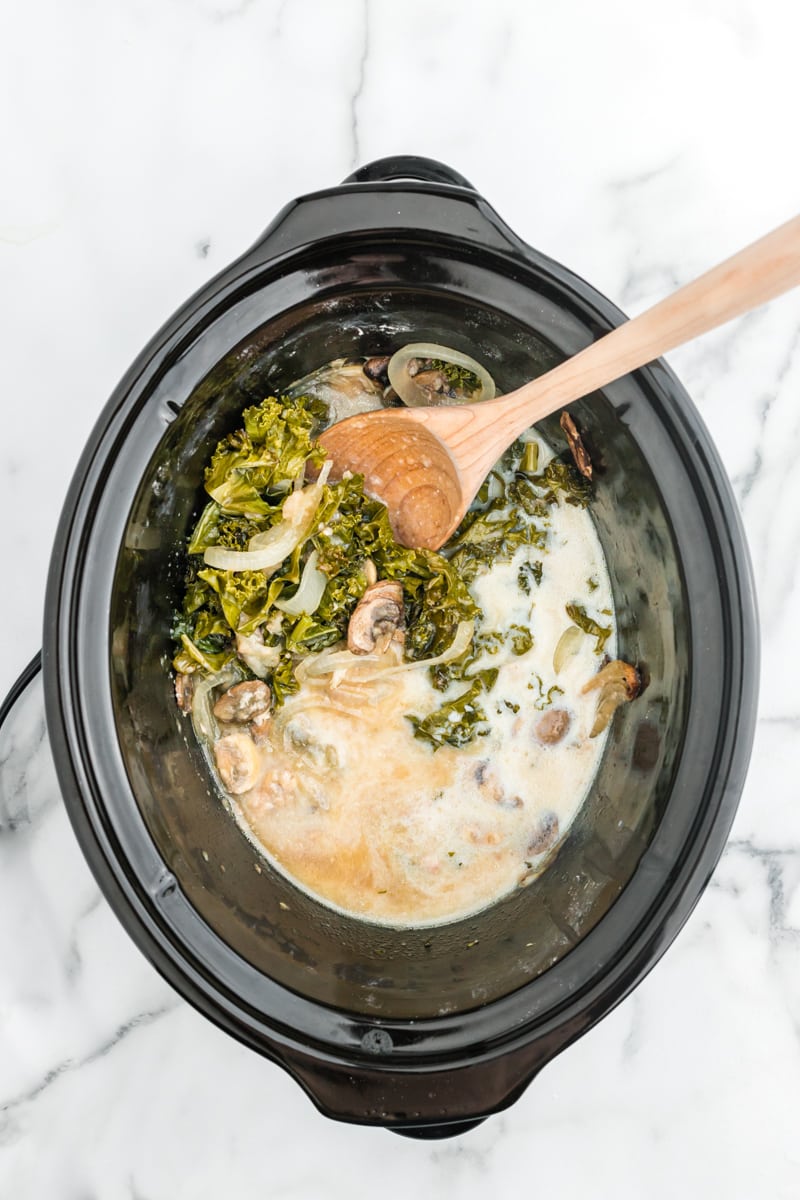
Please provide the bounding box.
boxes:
[4,157,758,1136]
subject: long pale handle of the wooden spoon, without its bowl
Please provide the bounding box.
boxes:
[482,216,800,452]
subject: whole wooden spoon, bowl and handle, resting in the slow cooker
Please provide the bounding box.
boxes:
[319,216,800,550]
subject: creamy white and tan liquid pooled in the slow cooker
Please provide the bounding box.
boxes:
[215,445,615,926]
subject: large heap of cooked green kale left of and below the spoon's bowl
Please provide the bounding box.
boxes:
[174,397,477,704]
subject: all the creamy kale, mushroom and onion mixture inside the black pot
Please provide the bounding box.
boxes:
[174,344,639,926]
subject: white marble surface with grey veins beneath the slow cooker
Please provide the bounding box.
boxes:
[0,0,800,1200]
